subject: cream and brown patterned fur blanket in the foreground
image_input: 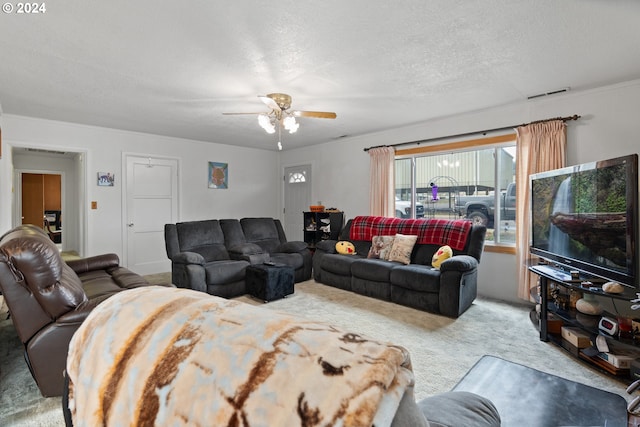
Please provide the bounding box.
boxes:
[67,287,413,427]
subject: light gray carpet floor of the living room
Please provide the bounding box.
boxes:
[0,273,628,426]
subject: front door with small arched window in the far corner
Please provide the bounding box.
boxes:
[283,165,311,241]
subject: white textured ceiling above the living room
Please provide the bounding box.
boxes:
[0,0,640,149]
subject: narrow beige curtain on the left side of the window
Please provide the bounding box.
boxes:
[369,147,396,217]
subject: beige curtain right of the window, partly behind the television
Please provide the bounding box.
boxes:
[516,120,567,300]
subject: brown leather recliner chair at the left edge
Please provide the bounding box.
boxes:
[0,225,170,397]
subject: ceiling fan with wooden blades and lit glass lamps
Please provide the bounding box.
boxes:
[222,93,337,149]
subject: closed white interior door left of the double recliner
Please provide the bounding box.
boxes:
[125,154,178,274]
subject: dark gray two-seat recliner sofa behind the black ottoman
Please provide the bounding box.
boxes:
[164,218,311,298]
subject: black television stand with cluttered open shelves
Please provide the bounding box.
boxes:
[529,264,640,384]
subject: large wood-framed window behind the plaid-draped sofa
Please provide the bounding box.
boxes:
[395,134,516,245]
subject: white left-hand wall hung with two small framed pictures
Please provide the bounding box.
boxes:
[0,114,280,257]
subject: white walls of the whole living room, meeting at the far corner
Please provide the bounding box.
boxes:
[0,80,640,302]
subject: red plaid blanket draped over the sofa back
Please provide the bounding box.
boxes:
[349,216,471,251]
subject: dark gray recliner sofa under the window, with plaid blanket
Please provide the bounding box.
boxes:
[313,217,486,318]
